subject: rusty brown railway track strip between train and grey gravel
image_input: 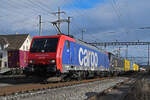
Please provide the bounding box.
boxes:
[0,78,109,96]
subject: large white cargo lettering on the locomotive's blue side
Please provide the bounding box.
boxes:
[78,48,98,67]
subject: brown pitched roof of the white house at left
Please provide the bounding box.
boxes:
[0,34,29,50]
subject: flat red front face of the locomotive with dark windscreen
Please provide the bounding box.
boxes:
[25,36,59,76]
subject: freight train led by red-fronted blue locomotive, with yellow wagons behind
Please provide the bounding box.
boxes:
[25,34,139,78]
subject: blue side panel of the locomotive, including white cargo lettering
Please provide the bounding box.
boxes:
[62,41,109,68]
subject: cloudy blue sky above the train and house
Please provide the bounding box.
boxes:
[0,0,150,64]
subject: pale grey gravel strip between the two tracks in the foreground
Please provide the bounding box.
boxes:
[0,77,128,100]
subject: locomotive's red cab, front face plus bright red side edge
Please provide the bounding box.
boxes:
[24,35,75,76]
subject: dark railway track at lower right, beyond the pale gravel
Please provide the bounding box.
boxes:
[88,73,145,100]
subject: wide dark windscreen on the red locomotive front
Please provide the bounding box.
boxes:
[30,38,58,53]
